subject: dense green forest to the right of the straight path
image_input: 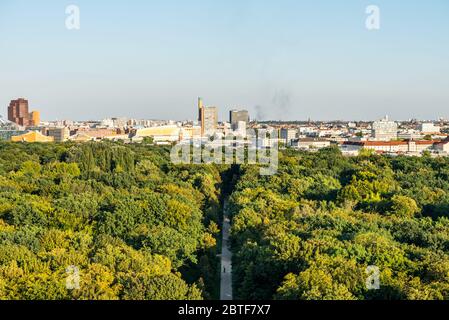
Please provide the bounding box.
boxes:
[230,148,449,300]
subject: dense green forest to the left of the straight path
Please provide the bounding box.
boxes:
[0,142,221,300]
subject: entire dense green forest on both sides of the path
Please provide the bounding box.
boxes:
[0,142,449,300]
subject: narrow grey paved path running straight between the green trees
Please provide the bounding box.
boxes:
[220,201,232,300]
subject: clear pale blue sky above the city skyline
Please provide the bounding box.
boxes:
[0,0,449,120]
